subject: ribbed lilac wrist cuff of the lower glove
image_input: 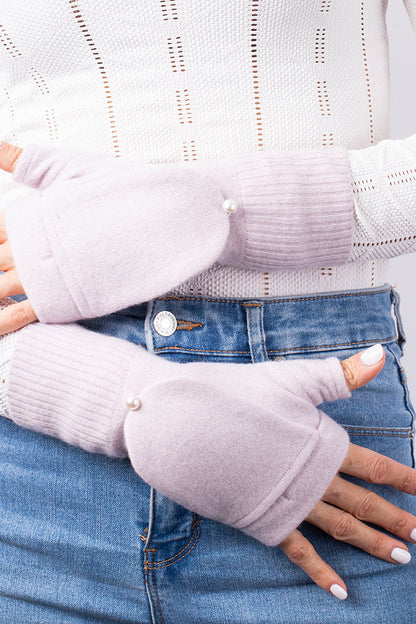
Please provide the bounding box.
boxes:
[8,323,149,457]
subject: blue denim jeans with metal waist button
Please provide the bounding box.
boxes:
[0,286,416,624]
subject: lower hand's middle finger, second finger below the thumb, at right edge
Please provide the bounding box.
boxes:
[322,475,416,542]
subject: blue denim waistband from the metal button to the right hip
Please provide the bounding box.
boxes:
[142,285,404,361]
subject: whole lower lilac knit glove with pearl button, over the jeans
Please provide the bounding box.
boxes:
[9,323,350,545]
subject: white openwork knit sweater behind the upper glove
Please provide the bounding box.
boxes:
[0,0,416,297]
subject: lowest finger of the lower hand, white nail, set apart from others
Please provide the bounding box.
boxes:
[279,530,348,600]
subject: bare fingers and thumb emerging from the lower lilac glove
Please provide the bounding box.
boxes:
[279,354,416,599]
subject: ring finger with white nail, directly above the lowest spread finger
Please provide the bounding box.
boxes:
[306,501,411,563]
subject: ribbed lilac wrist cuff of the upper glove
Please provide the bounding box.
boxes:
[212,147,354,270]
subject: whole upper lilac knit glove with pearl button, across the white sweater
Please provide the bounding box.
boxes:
[5,144,353,323]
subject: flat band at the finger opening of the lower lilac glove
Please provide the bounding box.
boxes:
[233,412,349,546]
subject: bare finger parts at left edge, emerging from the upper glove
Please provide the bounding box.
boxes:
[0,143,38,336]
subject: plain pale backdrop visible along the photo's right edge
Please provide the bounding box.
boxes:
[387,0,416,388]
